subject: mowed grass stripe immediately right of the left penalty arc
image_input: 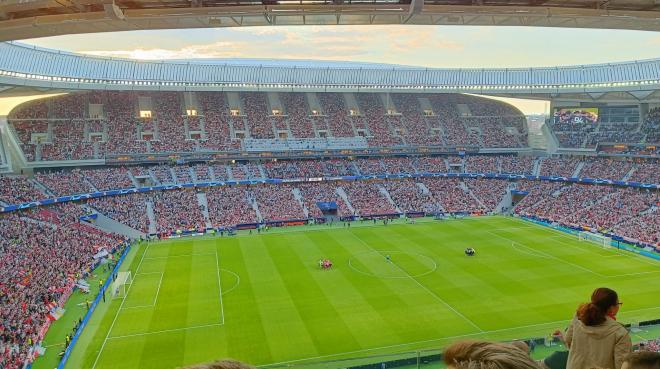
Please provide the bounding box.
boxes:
[239,237,319,360]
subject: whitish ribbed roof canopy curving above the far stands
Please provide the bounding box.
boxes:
[0,42,660,101]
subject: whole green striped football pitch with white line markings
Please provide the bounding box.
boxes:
[59,217,660,369]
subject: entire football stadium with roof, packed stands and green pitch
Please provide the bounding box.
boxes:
[0,0,660,369]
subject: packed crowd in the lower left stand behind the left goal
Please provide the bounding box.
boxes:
[0,213,122,369]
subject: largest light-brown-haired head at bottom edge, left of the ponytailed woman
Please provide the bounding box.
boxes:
[443,341,538,369]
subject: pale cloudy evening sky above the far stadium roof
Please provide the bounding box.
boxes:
[0,25,660,114]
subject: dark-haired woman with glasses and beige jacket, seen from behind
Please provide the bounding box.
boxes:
[565,287,632,369]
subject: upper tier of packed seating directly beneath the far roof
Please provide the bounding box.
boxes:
[9,91,526,161]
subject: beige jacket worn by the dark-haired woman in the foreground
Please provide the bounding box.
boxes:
[565,316,632,369]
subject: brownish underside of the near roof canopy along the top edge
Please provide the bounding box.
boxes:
[0,0,660,41]
